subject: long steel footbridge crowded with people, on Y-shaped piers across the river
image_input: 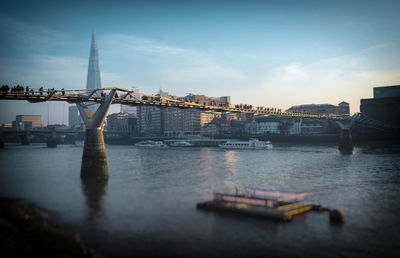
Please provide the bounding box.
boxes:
[0,86,390,178]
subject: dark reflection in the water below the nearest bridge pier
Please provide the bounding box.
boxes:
[81,178,108,224]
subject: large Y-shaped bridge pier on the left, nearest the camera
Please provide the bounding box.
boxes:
[76,90,116,179]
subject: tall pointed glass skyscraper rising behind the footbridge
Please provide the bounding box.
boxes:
[86,32,101,114]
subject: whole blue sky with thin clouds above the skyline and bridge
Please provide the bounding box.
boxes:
[0,0,400,124]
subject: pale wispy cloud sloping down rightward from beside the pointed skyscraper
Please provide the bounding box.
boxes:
[102,34,245,94]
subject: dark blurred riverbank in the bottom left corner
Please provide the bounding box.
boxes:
[0,197,103,257]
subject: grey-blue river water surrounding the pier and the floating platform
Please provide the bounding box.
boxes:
[0,144,400,257]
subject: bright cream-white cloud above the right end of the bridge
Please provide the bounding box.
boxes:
[256,44,400,112]
